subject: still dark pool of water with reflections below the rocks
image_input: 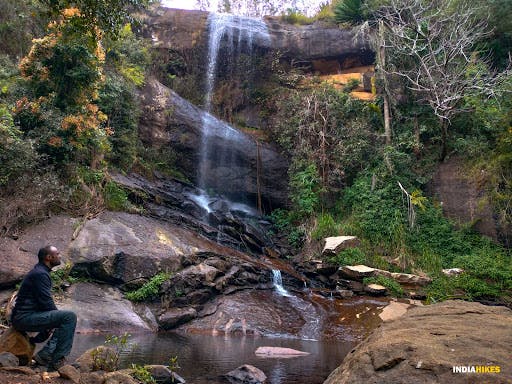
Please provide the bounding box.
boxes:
[71,333,355,384]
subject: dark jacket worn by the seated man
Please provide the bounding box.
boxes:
[12,263,57,325]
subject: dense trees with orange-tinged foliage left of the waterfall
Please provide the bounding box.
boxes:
[0,0,159,235]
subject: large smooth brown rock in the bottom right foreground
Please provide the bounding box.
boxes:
[324,301,512,384]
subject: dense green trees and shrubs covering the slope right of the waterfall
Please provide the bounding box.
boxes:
[266,0,512,304]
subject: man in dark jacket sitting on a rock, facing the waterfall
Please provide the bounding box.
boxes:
[11,246,76,371]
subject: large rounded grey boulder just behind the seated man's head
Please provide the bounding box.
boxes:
[69,212,188,283]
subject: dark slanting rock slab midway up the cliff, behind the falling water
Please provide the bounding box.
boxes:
[139,78,288,208]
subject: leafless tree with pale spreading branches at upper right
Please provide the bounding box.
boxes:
[376,0,508,159]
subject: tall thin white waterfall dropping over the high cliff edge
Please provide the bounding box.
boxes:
[198,13,271,196]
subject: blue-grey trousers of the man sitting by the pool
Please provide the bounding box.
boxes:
[13,310,76,364]
